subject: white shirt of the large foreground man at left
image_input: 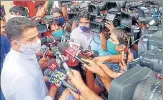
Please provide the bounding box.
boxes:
[1,49,53,100]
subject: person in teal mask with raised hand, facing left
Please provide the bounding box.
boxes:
[100,22,130,56]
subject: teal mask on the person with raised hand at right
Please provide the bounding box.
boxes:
[107,39,119,55]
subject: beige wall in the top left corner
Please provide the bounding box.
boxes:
[1,1,13,20]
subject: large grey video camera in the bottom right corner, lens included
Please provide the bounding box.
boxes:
[108,65,162,100]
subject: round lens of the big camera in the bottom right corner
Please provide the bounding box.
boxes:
[133,77,162,100]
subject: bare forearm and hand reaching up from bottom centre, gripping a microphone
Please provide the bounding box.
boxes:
[68,70,102,100]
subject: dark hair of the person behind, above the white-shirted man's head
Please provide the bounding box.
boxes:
[9,6,28,16]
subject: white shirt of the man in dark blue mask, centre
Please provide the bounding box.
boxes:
[70,27,93,50]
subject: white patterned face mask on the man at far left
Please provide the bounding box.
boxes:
[18,39,41,55]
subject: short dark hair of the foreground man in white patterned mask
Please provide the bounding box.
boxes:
[6,17,36,41]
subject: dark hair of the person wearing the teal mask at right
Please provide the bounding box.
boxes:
[115,28,130,46]
